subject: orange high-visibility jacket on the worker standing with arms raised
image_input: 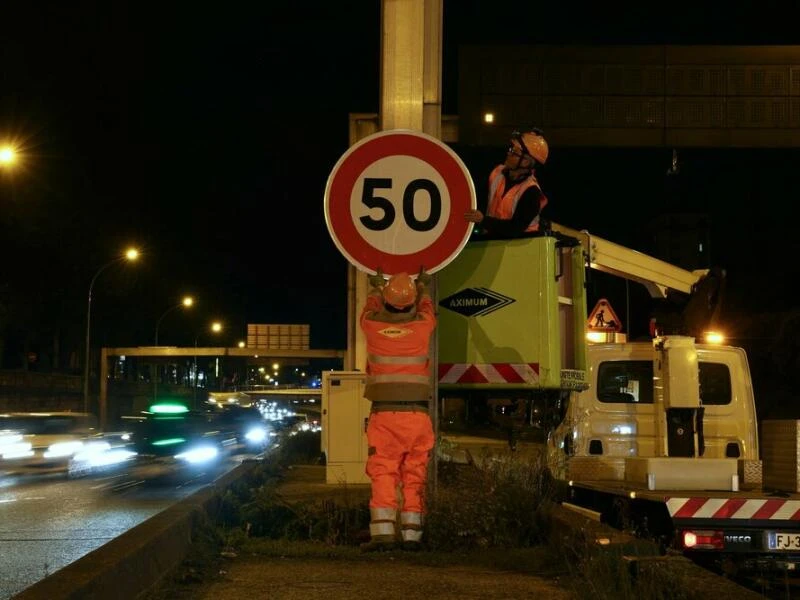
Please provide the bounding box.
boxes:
[361,293,436,402]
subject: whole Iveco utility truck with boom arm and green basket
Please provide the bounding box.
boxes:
[437,224,800,568]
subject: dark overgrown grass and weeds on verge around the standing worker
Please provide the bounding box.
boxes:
[145,433,690,600]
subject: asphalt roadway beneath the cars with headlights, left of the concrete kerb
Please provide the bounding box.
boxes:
[0,463,235,600]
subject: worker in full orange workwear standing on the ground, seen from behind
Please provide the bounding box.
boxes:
[360,269,436,551]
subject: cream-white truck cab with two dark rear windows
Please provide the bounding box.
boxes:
[548,342,758,480]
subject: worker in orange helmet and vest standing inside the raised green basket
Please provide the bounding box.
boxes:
[464,128,550,237]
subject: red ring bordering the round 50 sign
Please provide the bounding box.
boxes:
[328,133,474,275]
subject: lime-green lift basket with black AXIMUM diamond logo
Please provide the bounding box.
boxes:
[437,235,586,390]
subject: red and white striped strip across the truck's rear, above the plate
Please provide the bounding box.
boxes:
[667,498,800,521]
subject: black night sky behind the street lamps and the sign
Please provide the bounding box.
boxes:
[0,0,800,378]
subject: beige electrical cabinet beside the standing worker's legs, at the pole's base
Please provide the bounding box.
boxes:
[321,371,370,483]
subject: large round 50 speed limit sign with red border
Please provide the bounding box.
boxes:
[325,129,476,275]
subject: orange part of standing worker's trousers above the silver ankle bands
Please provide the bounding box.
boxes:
[366,411,434,513]
